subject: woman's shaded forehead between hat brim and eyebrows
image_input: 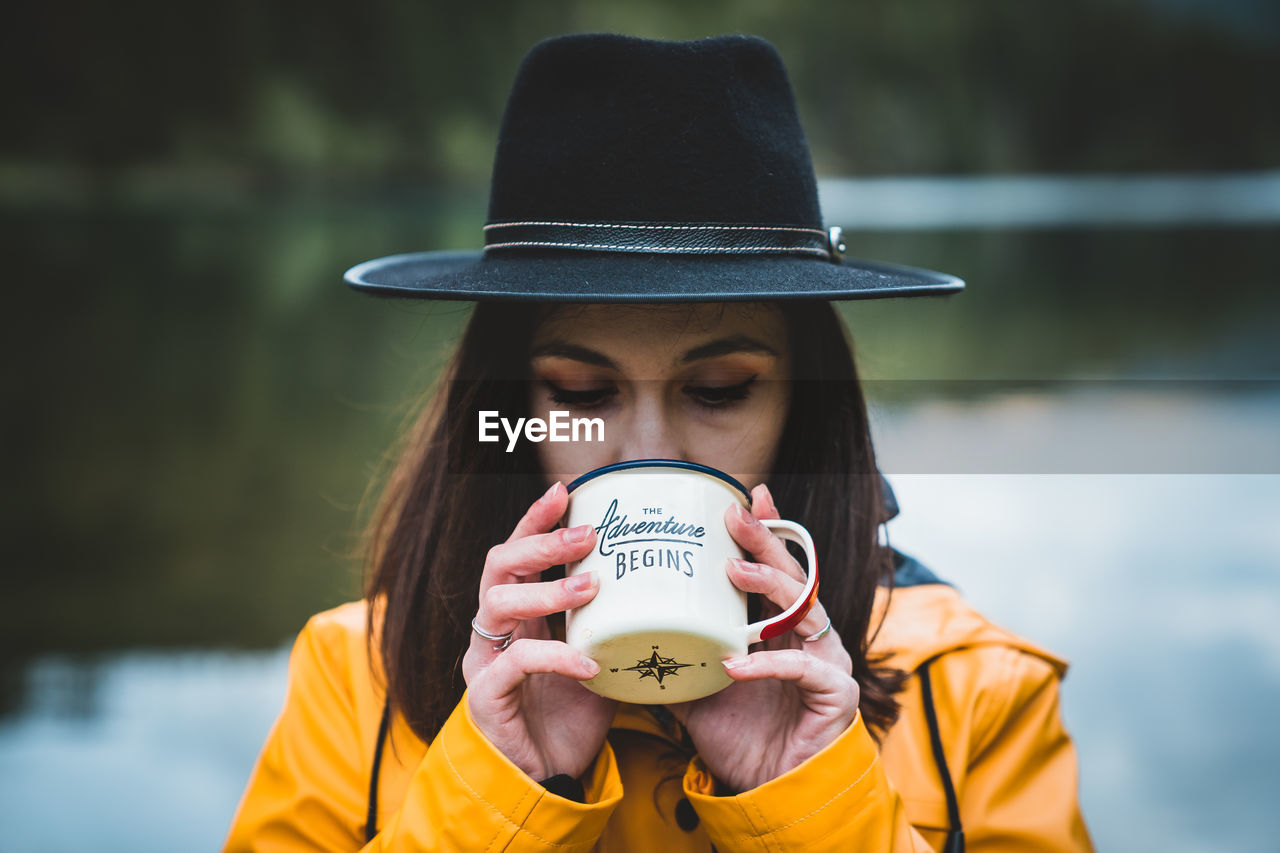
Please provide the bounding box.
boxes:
[532,302,788,357]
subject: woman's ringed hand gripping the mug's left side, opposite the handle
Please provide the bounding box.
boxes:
[462,483,617,781]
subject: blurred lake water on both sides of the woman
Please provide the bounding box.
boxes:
[0,175,1280,850]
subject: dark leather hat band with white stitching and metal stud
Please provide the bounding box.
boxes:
[484,222,844,263]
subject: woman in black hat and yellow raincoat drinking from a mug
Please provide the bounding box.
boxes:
[227,36,1091,850]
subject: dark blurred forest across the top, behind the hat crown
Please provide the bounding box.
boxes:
[0,0,1280,199]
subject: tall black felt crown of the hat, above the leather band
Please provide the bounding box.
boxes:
[489,35,822,228]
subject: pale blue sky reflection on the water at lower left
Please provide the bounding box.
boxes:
[0,651,287,853]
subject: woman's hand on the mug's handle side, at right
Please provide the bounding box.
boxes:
[671,484,859,792]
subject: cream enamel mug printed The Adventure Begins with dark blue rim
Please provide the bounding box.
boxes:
[566,459,818,704]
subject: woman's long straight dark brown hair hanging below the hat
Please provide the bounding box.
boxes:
[365,301,905,742]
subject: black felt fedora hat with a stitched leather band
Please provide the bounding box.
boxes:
[346,35,964,302]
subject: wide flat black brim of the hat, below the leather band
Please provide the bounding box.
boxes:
[343,251,964,302]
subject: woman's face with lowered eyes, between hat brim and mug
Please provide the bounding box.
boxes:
[530,302,791,488]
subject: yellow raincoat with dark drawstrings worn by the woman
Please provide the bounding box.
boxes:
[225,563,1092,853]
